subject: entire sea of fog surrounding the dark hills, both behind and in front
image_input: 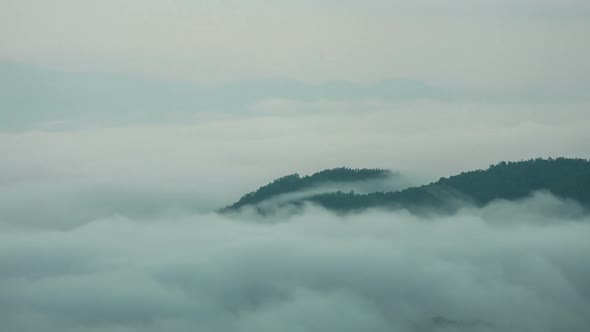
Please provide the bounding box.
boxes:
[0,107,590,332]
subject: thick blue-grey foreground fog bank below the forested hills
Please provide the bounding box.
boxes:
[0,193,590,332]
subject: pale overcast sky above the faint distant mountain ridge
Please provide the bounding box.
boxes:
[0,0,590,90]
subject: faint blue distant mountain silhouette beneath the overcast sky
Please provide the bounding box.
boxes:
[0,60,458,132]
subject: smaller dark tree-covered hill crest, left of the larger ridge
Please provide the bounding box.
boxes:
[223,167,393,211]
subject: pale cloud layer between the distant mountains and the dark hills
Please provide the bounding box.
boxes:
[0,103,590,229]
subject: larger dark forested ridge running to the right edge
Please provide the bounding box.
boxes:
[225,158,590,213]
